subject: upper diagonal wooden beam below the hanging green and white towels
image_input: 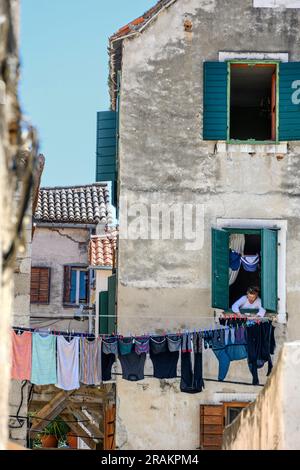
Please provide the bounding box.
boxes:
[30,391,73,432]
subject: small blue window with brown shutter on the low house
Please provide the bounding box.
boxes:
[64,266,89,306]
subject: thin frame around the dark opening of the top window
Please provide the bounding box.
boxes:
[226,59,281,145]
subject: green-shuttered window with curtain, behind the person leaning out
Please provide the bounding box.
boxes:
[212,228,278,313]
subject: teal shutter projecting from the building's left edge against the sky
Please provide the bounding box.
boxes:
[96,111,117,183]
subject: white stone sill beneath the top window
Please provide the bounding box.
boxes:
[217,142,288,155]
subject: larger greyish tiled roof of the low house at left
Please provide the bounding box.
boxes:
[34,184,113,224]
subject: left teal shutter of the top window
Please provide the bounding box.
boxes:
[203,62,228,140]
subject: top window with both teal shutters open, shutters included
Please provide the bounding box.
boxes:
[203,61,300,143]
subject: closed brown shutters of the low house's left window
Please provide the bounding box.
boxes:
[30,267,50,305]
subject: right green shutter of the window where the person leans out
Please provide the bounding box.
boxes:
[261,229,278,312]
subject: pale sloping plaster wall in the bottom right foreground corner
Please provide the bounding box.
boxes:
[223,341,300,450]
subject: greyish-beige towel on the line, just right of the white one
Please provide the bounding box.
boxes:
[80,338,102,385]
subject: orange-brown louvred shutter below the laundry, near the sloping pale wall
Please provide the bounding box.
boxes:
[200,405,224,450]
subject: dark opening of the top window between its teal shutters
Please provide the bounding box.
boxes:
[229,63,277,141]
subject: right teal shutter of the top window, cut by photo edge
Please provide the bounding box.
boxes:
[279,62,300,140]
